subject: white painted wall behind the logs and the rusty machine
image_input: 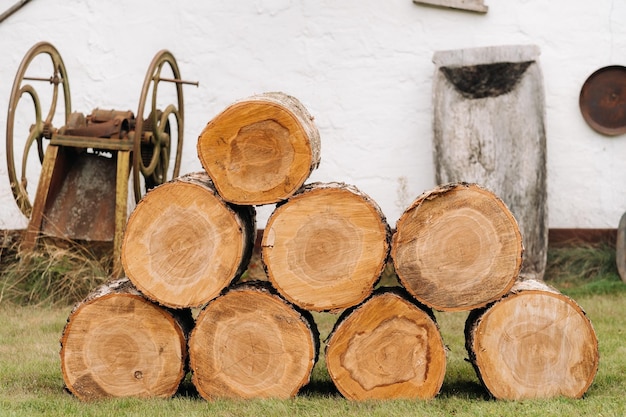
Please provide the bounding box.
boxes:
[0,0,626,229]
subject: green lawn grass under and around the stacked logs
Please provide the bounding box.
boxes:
[0,242,626,417]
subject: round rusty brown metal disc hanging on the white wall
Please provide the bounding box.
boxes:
[579,65,626,136]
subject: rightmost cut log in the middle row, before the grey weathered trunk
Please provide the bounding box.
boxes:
[391,183,524,311]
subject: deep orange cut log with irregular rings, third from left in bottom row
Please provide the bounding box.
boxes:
[326,288,446,400]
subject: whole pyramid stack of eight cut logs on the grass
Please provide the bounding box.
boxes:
[61,93,598,400]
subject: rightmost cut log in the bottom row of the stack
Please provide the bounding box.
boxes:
[465,280,599,400]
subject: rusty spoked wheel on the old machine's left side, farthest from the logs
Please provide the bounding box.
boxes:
[6,42,72,218]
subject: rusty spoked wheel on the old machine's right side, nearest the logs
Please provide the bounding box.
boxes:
[132,50,185,202]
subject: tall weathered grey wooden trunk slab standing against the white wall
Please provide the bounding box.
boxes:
[433,45,548,279]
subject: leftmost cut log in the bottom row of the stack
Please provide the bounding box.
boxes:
[61,278,193,401]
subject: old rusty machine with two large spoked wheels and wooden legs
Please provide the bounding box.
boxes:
[6,42,198,276]
